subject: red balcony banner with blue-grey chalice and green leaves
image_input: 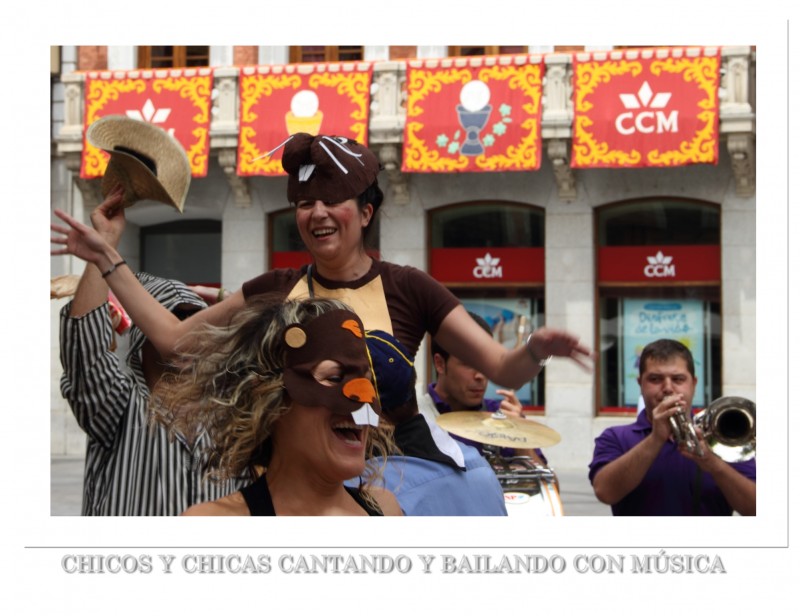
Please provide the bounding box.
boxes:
[402,55,544,173]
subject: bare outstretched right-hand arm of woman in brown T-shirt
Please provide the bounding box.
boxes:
[436,306,594,389]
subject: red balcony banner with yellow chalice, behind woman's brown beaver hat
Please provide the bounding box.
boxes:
[236,62,372,176]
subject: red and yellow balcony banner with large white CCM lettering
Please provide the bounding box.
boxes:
[571,47,720,168]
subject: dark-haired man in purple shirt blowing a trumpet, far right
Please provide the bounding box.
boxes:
[589,339,756,515]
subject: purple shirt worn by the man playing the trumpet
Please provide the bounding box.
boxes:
[589,413,756,515]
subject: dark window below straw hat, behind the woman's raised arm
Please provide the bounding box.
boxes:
[140,220,222,286]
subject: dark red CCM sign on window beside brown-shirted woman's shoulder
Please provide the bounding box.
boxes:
[430,248,544,284]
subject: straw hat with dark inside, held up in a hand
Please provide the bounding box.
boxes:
[86,115,192,212]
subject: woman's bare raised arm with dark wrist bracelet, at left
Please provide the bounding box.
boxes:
[50,199,244,358]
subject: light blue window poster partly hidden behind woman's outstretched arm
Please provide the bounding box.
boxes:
[461,298,538,405]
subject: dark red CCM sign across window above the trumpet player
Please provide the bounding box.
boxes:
[597,245,722,285]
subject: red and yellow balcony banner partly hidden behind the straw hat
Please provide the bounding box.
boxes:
[80,68,213,179]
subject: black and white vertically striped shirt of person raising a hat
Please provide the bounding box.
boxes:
[60,273,249,515]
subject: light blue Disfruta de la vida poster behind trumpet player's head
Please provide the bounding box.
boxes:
[622,299,706,407]
